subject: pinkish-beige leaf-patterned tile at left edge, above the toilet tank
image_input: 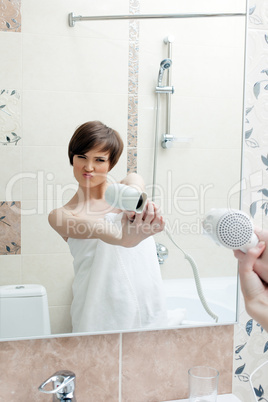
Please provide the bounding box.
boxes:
[0,201,21,255]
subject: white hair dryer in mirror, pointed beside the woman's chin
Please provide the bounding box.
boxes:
[104,183,147,214]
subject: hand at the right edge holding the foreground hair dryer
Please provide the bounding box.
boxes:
[234,231,268,331]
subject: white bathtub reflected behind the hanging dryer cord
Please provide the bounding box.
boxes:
[164,276,237,326]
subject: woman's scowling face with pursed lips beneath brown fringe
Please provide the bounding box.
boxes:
[73,148,110,188]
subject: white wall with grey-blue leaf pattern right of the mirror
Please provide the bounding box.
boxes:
[233,0,268,402]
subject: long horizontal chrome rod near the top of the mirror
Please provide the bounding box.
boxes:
[68,12,246,27]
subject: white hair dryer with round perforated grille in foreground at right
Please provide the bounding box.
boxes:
[202,208,259,253]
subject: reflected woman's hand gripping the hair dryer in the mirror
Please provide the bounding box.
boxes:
[122,201,165,247]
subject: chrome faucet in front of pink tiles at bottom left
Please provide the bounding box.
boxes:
[38,370,76,402]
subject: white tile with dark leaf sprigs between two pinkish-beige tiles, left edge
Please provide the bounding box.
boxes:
[0,89,21,145]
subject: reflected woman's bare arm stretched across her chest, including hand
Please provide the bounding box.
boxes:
[48,202,165,247]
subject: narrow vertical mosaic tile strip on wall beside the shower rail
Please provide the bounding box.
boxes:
[127,0,140,173]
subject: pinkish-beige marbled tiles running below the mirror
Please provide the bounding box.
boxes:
[0,325,233,402]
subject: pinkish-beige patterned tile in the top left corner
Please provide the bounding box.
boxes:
[0,0,21,32]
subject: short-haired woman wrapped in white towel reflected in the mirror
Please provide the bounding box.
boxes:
[49,121,166,332]
